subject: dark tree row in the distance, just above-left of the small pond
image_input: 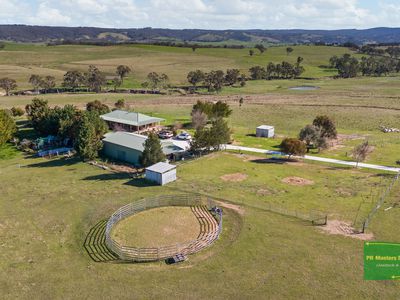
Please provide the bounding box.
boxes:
[249,56,304,80]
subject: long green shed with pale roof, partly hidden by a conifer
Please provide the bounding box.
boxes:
[103,131,186,166]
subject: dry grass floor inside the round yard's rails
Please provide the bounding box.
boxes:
[111,207,200,248]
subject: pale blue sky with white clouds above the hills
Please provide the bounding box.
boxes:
[0,0,400,29]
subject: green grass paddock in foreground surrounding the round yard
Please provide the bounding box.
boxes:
[0,149,400,299]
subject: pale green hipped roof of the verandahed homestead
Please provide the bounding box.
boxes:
[100,110,164,126]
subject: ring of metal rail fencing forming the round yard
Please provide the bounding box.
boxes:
[105,195,222,262]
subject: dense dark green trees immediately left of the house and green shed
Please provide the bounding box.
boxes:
[25,98,109,159]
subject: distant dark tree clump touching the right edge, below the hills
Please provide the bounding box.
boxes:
[329,54,400,78]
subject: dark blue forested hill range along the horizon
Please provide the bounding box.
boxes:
[0,25,400,45]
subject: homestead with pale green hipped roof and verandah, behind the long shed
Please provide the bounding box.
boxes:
[100,110,164,133]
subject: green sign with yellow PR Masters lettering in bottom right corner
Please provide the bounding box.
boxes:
[364,242,400,280]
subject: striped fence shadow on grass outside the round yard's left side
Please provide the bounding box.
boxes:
[83,220,122,262]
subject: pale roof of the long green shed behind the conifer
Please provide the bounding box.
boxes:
[103,131,185,155]
